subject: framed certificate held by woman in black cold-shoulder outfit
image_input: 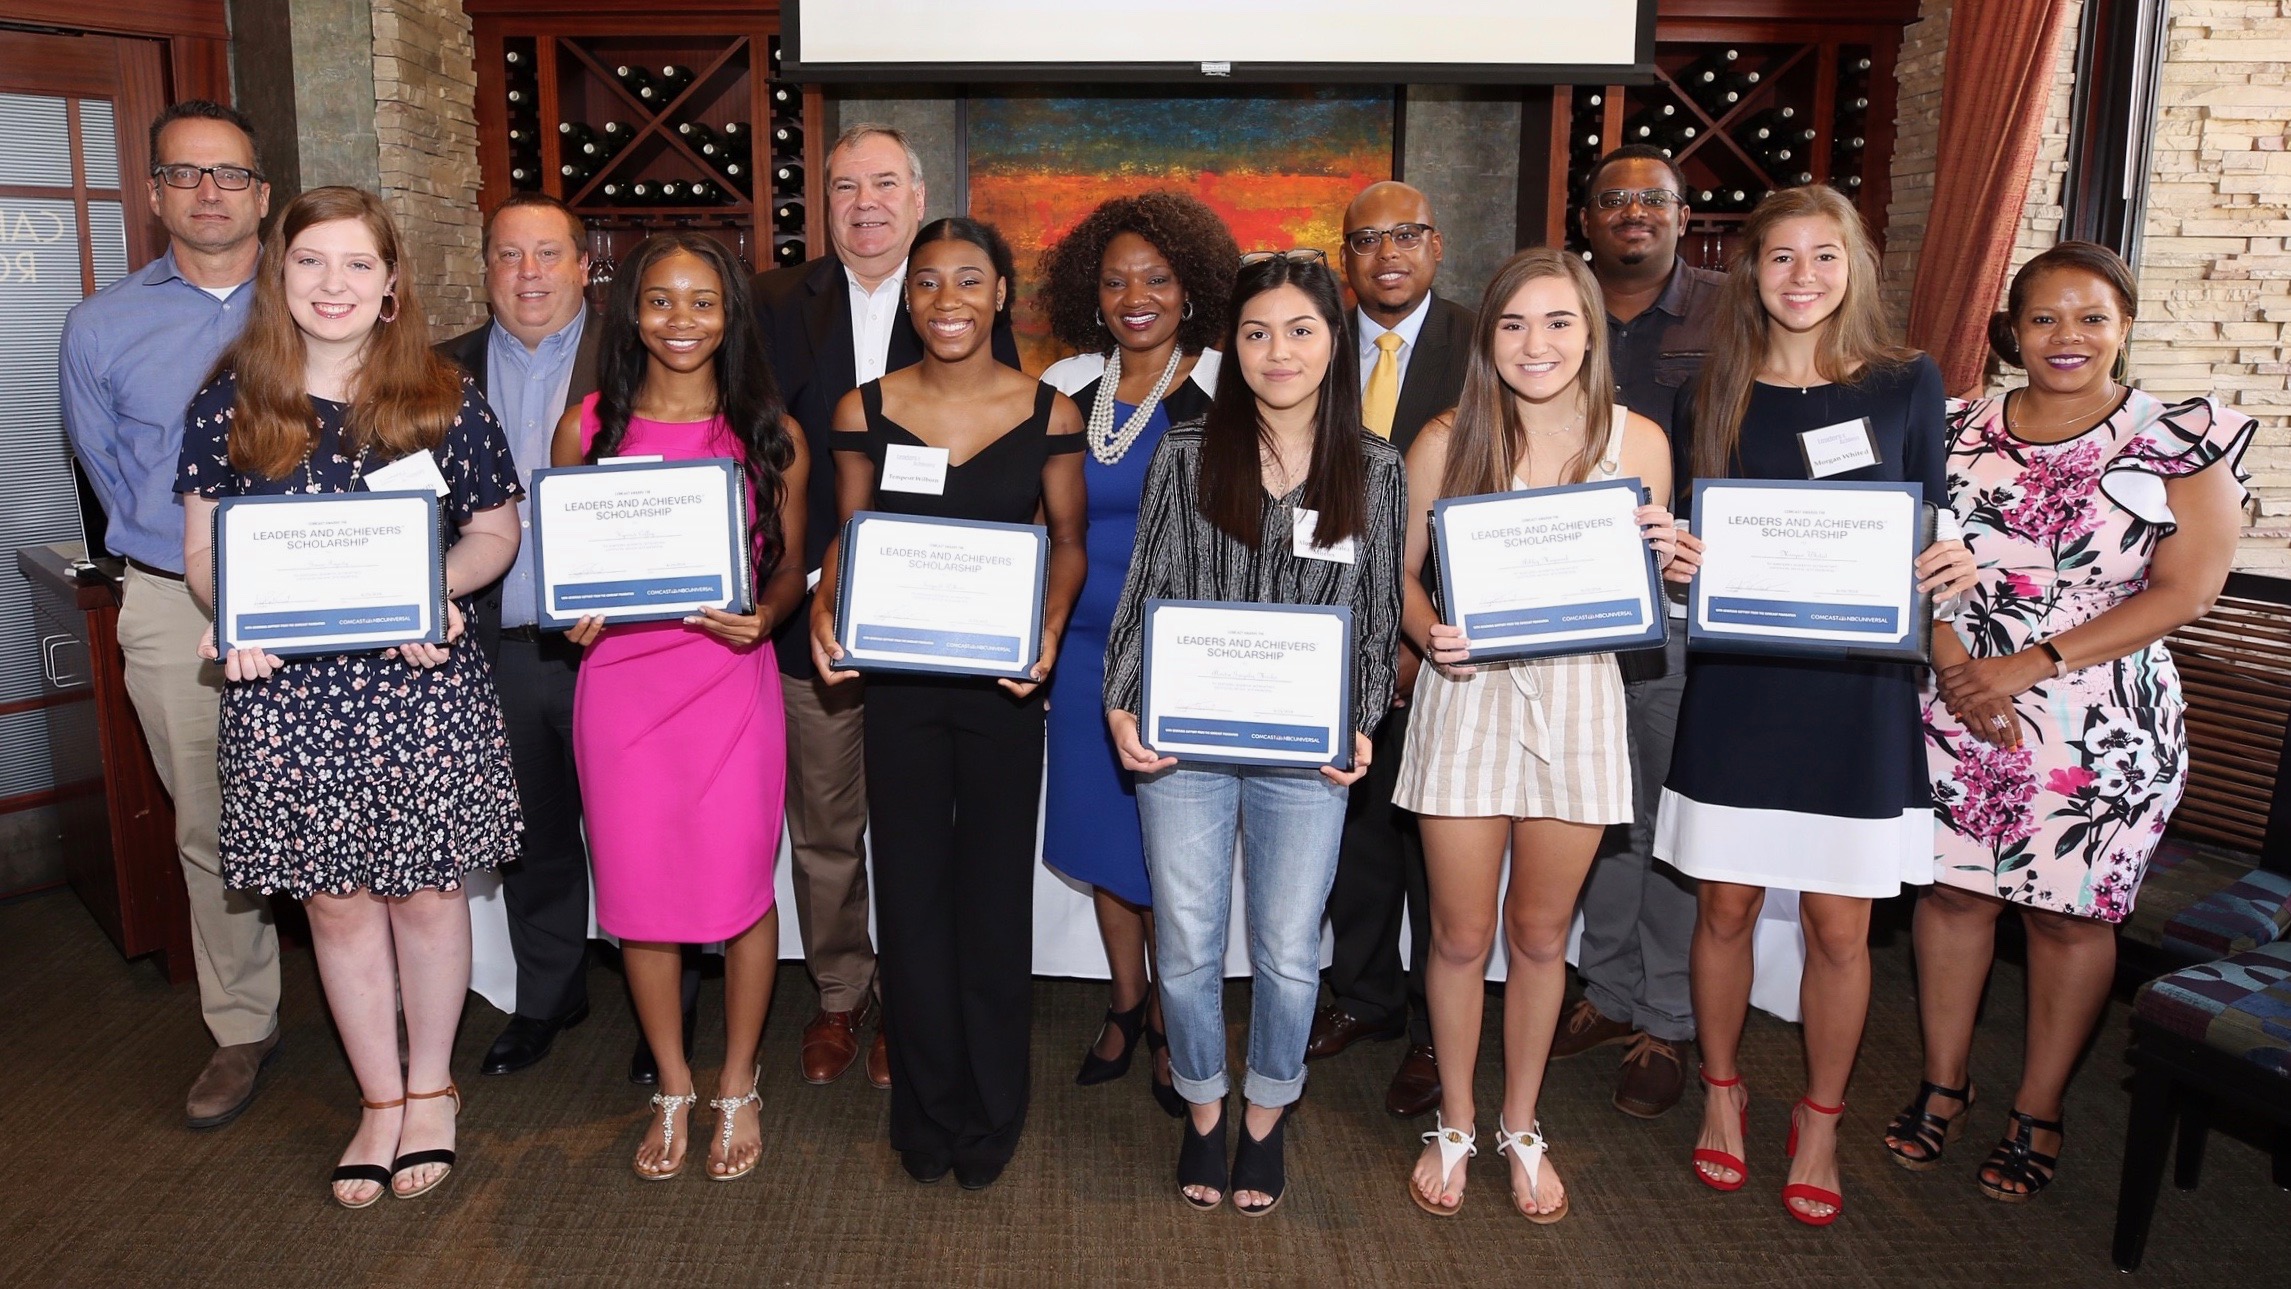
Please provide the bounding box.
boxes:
[834,511,1049,680]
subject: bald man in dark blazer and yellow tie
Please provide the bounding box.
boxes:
[1306,183,1478,1117]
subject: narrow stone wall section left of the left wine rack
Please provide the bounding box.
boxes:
[373,0,486,337]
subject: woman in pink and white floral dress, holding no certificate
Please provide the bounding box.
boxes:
[1885,243,2252,1202]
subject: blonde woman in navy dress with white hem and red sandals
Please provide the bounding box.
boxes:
[1654,185,1973,1227]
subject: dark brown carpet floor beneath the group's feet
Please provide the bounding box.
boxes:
[0,893,2291,1289]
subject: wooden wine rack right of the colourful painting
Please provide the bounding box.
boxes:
[1521,0,1915,268]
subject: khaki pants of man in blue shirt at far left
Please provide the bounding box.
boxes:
[119,566,280,1046]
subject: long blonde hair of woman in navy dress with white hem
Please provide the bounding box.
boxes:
[1695,183,1918,479]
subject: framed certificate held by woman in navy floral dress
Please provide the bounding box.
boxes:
[215,490,444,657]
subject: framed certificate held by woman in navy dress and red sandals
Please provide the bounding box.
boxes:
[1686,479,1934,662]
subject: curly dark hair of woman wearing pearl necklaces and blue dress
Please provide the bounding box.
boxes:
[1042,190,1242,353]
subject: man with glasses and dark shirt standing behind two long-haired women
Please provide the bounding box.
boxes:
[1551,144,1725,1120]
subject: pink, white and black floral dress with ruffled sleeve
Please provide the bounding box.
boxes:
[1924,389,2252,923]
